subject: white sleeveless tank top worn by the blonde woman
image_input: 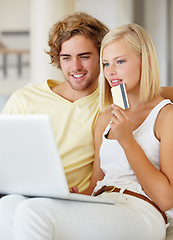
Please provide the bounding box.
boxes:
[94,99,173,217]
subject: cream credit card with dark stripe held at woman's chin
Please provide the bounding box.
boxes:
[111,83,129,109]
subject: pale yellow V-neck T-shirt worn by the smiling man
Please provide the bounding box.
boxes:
[1,80,99,191]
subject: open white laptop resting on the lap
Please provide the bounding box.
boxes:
[0,114,115,204]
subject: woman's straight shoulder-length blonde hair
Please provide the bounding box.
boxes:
[100,23,161,111]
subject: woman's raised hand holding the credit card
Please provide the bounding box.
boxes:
[110,104,133,145]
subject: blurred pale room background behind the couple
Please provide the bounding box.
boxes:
[0,0,173,111]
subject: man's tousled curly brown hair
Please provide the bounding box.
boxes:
[46,12,109,68]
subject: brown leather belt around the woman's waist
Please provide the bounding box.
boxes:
[93,186,168,224]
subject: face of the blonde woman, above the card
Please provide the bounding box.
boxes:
[102,39,141,92]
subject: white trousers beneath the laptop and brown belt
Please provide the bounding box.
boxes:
[0,193,166,240]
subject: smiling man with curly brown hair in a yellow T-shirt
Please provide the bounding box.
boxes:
[2,13,173,192]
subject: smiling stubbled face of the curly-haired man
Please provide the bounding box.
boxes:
[60,35,100,92]
